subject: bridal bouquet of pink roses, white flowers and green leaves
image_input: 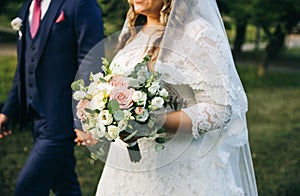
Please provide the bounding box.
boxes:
[72,56,173,162]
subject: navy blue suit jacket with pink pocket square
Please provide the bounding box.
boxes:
[2,0,104,139]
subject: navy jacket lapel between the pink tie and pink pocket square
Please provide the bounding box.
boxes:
[36,0,64,61]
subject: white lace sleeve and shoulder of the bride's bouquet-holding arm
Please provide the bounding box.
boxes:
[157,20,244,138]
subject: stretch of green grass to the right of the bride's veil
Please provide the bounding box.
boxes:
[239,67,300,196]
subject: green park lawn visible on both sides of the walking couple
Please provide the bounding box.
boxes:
[0,57,300,196]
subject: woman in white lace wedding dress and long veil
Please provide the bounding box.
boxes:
[76,0,258,196]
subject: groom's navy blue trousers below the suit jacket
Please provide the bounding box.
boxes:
[15,115,81,196]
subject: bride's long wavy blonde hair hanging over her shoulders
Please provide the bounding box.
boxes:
[117,0,174,65]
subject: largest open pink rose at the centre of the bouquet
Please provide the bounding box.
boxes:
[110,87,134,109]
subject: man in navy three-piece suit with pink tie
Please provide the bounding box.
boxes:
[0,0,104,196]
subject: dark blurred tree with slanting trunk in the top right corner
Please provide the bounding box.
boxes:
[252,0,300,76]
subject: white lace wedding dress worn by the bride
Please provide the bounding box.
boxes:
[96,17,256,196]
